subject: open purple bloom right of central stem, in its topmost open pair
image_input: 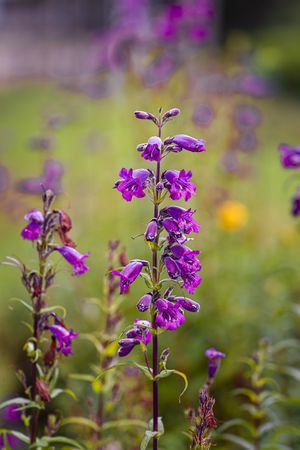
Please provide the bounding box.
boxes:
[162,170,196,201]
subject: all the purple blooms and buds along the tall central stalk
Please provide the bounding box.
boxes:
[112,108,205,356]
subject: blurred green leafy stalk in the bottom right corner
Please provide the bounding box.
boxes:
[215,339,300,450]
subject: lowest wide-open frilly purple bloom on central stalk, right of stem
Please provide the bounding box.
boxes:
[155,298,185,330]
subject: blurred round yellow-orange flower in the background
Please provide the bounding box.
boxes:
[217,200,248,231]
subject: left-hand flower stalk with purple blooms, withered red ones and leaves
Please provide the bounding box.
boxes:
[0,190,89,448]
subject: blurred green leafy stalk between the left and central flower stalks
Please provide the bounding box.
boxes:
[61,241,147,450]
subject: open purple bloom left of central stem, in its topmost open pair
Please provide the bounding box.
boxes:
[115,167,150,202]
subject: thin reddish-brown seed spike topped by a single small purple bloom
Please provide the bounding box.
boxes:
[187,348,225,450]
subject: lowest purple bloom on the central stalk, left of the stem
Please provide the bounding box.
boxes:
[118,319,152,357]
